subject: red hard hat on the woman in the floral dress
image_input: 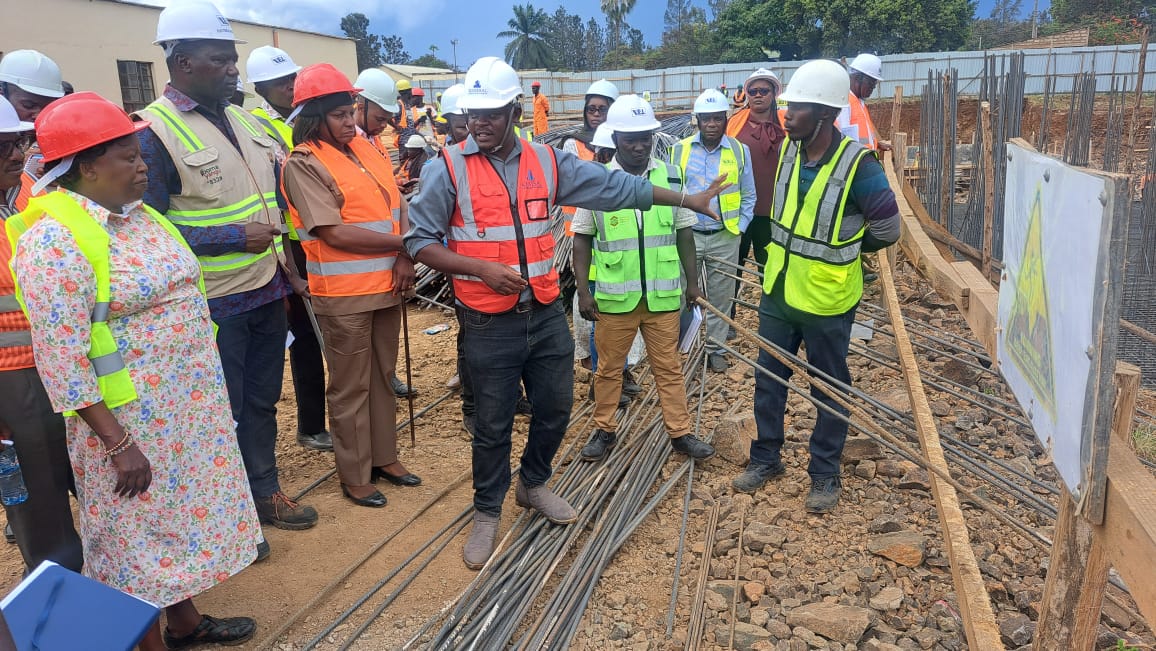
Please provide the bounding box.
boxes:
[36,90,149,163]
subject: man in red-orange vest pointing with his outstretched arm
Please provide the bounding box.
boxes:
[405,57,724,569]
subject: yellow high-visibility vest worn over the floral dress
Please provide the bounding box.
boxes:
[5,192,205,416]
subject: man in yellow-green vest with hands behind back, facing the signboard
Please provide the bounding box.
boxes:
[732,60,899,513]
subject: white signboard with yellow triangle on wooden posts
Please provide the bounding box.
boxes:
[996,145,1114,500]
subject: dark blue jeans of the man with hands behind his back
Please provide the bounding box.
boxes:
[750,283,855,479]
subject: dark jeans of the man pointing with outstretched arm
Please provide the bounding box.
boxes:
[461,301,575,515]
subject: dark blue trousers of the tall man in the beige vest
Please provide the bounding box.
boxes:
[216,299,289,498]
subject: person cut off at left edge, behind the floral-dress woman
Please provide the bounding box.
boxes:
[0,97,83,572]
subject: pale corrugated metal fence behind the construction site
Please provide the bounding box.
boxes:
[414,45,1156,113]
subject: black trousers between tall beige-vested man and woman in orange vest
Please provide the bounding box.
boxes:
[289,239,325,434]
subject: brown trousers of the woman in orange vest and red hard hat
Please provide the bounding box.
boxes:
[317,305,401,487]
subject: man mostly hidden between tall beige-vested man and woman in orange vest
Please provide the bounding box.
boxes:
[245,45,333,451]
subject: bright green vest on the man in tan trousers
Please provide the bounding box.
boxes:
[593,161,682,315]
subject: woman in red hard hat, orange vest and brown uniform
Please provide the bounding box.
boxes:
[282,64,421,508]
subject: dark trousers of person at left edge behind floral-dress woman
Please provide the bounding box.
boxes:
[0,369,84,572]
